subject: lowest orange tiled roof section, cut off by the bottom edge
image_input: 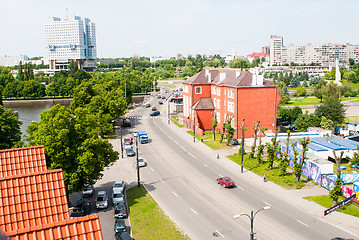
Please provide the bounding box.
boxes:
[7,214,103,240]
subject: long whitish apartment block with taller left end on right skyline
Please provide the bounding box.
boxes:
[270,36,359,67]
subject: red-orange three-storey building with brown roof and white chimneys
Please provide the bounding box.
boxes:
[183,69,280,138]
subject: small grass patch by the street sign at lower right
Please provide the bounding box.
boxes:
[304,195,359,217]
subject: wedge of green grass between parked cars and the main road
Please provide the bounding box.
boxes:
[126,185,189,240]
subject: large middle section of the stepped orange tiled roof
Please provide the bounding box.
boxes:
[0,169,70,232]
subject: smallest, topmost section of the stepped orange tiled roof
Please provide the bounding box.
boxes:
[0,146,47,177]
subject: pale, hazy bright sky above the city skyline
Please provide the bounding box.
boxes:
[0,0,359,58]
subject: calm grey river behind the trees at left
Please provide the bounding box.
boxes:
[3,99,71,135]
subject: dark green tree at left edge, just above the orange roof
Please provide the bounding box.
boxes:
[0,105,22,149]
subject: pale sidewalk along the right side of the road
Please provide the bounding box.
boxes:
[163,113,359,239]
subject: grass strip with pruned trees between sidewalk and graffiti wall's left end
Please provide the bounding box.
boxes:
[226,153,312,189]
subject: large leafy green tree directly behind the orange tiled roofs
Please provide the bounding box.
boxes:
[27,105,118,194]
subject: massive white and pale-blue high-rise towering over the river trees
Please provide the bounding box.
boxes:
[45,16,97,71]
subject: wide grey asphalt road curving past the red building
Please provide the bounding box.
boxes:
[73,91,359,239]
